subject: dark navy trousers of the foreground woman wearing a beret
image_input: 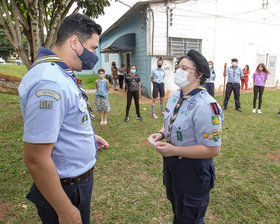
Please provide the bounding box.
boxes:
[163,156,215,224]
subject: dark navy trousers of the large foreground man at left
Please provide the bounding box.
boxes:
[26,173,93,224]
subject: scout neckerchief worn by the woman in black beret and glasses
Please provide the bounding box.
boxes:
[166,86,206,142]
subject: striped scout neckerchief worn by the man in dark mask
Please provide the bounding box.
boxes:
[30,47,95,122]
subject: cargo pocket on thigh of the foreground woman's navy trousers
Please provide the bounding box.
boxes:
[182,194,209,220]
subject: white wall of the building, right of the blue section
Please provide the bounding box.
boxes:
[148,0,280,93]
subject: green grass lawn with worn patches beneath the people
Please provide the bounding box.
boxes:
[0,90,280,224]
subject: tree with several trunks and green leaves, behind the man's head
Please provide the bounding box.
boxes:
[0,0,110,68]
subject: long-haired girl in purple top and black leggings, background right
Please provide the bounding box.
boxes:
[252,63,269,114]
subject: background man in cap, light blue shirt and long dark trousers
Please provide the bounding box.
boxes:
[224,58,244,112]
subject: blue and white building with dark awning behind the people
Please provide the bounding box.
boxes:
[90,0,280,97]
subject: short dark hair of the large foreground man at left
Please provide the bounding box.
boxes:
[56,13,102,45]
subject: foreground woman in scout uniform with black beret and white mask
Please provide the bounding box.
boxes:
[150,50,223,224]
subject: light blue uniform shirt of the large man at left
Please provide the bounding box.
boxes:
[18,62,96,178]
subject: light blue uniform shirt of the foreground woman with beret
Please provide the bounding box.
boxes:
[164,90,224,146]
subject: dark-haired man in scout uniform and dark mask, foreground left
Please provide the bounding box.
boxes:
[18,14,109,224]
